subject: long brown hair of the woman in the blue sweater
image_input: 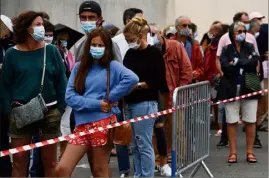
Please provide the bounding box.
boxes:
[75,27,114,95]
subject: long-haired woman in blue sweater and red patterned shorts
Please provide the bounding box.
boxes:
[56,28,138,177]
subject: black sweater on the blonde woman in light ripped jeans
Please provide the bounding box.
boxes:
[123,46,169,103]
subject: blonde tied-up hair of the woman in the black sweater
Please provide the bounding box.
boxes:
[123,17,149,35]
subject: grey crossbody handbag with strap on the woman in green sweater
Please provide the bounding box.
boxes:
[11,45,48,129]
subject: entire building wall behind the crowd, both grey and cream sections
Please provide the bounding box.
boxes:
[1,0,268,36]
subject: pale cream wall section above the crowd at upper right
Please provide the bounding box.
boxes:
[171,0,268,38]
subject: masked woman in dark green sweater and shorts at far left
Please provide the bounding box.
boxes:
[1,11,67,177]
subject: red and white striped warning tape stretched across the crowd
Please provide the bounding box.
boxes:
[0,89,268,157]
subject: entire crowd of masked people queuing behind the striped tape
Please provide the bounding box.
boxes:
[0,1,268,177]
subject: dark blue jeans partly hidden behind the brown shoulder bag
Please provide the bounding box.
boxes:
[115,102,130,174]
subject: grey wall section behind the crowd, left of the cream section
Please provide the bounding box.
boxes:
[1,0,167,30]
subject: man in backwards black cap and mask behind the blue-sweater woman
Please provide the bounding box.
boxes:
[74,1,122,62]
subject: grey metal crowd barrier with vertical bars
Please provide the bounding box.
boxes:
[172,82,213,178]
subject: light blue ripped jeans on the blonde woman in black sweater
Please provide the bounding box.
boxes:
[127,101,158,177]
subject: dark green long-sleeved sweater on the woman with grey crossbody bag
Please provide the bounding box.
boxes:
[2,45,67,113]
